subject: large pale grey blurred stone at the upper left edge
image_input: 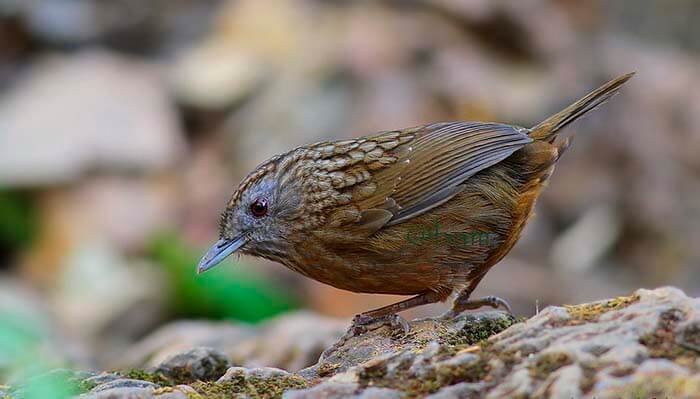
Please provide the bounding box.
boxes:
[0,51,185,186]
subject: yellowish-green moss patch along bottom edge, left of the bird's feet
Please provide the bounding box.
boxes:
[190,376,309,399]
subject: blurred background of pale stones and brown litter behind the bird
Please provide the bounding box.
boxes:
[0,0,700,392]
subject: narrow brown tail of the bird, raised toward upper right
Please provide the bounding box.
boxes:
[530,72,634,141]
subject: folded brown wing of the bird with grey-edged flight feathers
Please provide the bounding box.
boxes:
[357,122,532,231]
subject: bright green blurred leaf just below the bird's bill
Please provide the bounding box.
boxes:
[149,234,297,322]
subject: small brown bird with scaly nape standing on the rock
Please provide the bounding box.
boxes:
[198,73,633,326]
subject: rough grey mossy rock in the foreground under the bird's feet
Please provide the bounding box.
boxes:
[9,288,700,399]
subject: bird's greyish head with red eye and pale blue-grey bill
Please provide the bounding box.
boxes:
[197,161,302,273]
